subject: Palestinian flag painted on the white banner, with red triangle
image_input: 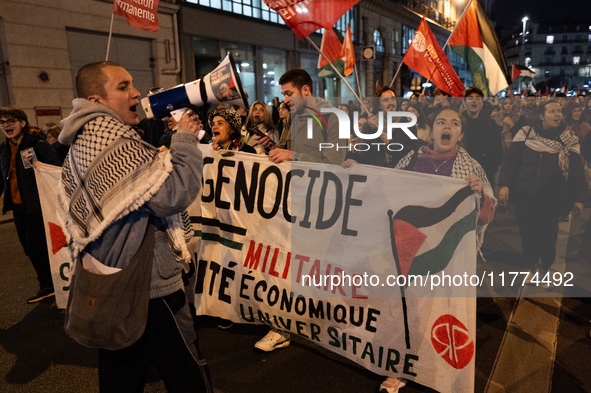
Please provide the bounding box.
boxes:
[391,186,478,276]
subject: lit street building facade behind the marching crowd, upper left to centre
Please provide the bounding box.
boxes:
[0,0,469,137]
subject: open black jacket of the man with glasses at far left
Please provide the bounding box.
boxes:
[0,133,62,214]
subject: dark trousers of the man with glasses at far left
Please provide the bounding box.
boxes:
[12,205,53,289]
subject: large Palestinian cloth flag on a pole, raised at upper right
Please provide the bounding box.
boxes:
[449,0,509,96]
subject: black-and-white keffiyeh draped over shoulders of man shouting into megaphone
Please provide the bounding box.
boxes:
[58,115,190,262]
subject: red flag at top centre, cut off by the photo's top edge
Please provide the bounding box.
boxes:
[264,0,359,40]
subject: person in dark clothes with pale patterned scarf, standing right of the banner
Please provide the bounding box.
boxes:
[499,100,588,280]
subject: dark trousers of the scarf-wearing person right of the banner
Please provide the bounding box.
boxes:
[515,198,560,270]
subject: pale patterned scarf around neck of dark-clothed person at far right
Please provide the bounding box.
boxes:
[513,127,581,179]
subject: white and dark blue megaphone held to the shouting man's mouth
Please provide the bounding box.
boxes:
[141,52,249,119]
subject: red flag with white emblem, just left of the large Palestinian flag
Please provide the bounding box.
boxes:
[402,17,464,97]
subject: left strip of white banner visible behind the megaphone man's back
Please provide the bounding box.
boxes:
[35,162,72,308]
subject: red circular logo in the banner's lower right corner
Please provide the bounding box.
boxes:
[431,314,474,369]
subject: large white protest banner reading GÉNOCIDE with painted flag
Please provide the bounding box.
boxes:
[191,146,478,392]
